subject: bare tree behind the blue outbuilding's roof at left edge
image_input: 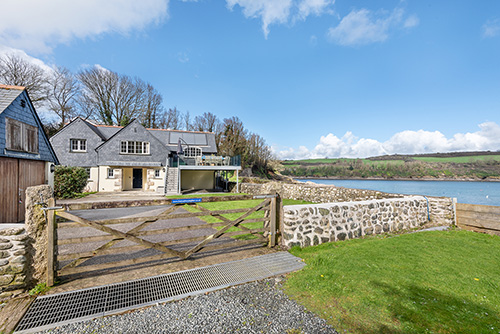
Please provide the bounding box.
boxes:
[0,53,48,107]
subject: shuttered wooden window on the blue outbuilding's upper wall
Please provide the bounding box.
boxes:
[5,117,38,153]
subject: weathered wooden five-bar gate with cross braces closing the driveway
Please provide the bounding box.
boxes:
[47,195,281,285]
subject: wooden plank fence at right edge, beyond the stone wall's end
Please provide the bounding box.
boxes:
[456,203,500,235]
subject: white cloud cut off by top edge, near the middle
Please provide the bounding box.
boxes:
[226,0,335,38]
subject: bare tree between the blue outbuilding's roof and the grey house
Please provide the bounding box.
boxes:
[48,67,80,127]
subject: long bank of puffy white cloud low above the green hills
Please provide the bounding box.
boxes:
[275,122,500,159]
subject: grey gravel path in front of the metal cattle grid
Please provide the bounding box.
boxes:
[38,277,337,334]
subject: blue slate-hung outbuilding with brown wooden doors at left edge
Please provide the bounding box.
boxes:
[0,85,58,223]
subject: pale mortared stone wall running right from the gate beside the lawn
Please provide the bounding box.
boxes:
[281,196,427,247]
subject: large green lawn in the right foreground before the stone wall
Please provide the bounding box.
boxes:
[285,230,500,334]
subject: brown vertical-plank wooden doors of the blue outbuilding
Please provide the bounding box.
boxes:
[0,157,45,223]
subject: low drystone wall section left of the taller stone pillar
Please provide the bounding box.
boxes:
[0,227,29,300]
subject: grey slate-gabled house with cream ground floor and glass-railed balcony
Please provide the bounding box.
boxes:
[50,117,241,194]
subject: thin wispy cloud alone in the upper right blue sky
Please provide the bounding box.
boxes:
[327,8,419,46]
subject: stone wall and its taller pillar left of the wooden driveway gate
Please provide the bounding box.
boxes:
[0,185,53,301]
